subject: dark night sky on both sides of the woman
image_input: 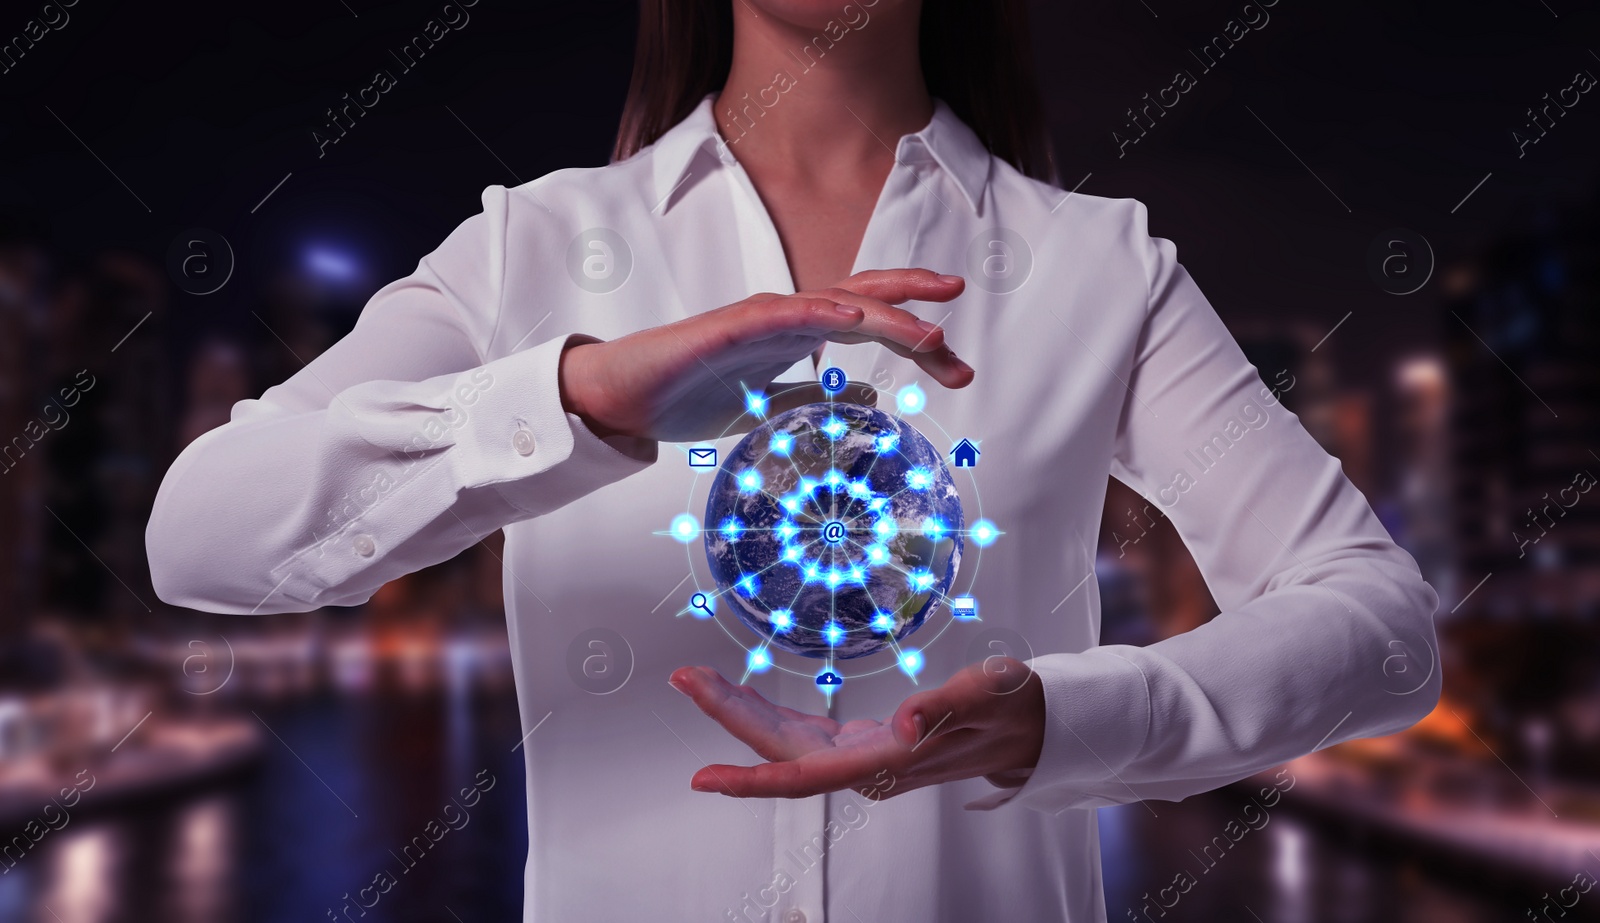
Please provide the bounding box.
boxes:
[0,0,1600,390]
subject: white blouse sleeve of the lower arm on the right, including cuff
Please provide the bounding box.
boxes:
[974,205,1440,811]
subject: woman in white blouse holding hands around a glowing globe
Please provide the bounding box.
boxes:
[149,0,1438,923]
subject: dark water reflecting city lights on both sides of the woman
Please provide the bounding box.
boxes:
[0,684,1548,923]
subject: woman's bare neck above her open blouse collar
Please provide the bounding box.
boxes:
[715,0,933,181]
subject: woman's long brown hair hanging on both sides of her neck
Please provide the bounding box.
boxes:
[611,0,1056,182]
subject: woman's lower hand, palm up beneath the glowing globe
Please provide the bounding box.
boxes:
[670,656,1045,798]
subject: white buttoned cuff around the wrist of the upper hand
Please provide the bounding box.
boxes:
[453,334,658,520]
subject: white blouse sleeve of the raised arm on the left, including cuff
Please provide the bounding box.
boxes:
[146,186,656,613]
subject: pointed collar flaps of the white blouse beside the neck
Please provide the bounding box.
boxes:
[651,94,992,214]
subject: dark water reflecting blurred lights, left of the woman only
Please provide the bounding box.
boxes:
[0,686,528,923]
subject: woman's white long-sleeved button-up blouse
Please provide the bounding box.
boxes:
[147,98,1438,923]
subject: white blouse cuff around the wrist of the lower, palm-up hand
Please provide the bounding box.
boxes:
[966,648,1150,814]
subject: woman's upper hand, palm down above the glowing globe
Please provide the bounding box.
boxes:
[560,269,974,442]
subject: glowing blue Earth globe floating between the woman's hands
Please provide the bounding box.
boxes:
[704,402,963,659]
